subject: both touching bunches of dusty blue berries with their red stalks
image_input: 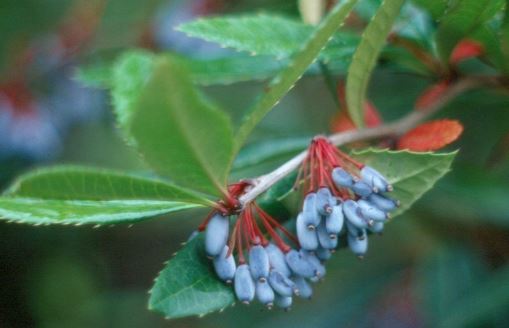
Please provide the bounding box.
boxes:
[199,137,398,309]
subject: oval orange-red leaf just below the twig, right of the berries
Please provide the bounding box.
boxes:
[397,120,463,152]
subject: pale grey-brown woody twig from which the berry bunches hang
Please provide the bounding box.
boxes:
[239,78,484,206]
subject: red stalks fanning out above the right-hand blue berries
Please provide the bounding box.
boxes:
[294,136,364,200]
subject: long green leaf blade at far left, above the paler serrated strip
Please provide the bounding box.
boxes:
[7,166,212,205]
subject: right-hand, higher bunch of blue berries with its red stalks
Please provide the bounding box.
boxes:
[297,137,399,259]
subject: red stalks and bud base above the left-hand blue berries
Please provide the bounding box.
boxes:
[198,181,299,264]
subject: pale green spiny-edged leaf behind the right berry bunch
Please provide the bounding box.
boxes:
[354,149,456,216]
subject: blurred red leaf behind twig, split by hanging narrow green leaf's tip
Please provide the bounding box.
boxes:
[330,83,382,132]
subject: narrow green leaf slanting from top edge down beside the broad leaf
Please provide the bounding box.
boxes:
[235,0,357,149]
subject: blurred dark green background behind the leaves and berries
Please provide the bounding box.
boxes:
[0,0,509,328]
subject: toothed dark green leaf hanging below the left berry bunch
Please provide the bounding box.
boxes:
[149,236,235,319]
